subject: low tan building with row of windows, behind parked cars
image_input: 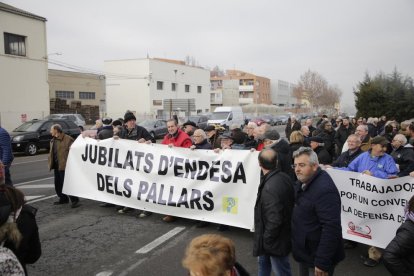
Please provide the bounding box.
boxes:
[49,69,106,123]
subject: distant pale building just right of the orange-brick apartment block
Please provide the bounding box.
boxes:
[270,80,297,108]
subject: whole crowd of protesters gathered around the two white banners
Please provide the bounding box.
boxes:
[0,111,414,275]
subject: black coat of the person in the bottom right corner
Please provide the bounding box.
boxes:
[382,220,414,276]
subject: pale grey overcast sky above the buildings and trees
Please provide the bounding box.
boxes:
[4,0,414,112]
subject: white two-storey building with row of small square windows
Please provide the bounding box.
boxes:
[104,58,210,119]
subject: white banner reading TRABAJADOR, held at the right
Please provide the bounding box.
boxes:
[327,169,414,248]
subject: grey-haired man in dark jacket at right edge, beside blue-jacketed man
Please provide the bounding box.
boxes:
[391,134,414,177]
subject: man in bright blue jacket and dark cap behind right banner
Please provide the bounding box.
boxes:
[339,136,398,179]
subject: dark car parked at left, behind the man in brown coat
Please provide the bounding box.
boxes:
[10,119,80,155]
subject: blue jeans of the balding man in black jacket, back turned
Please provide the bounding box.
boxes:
[258,255,292,276]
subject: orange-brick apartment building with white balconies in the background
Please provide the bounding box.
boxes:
[211,70,272,105]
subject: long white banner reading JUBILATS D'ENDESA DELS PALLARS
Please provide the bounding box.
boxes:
[63,136,260,230]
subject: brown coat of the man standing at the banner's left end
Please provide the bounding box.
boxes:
[48,133,73,171]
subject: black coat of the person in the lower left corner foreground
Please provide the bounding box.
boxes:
[4,204,42,274]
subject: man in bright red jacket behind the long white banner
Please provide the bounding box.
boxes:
[161,119,193,222]
